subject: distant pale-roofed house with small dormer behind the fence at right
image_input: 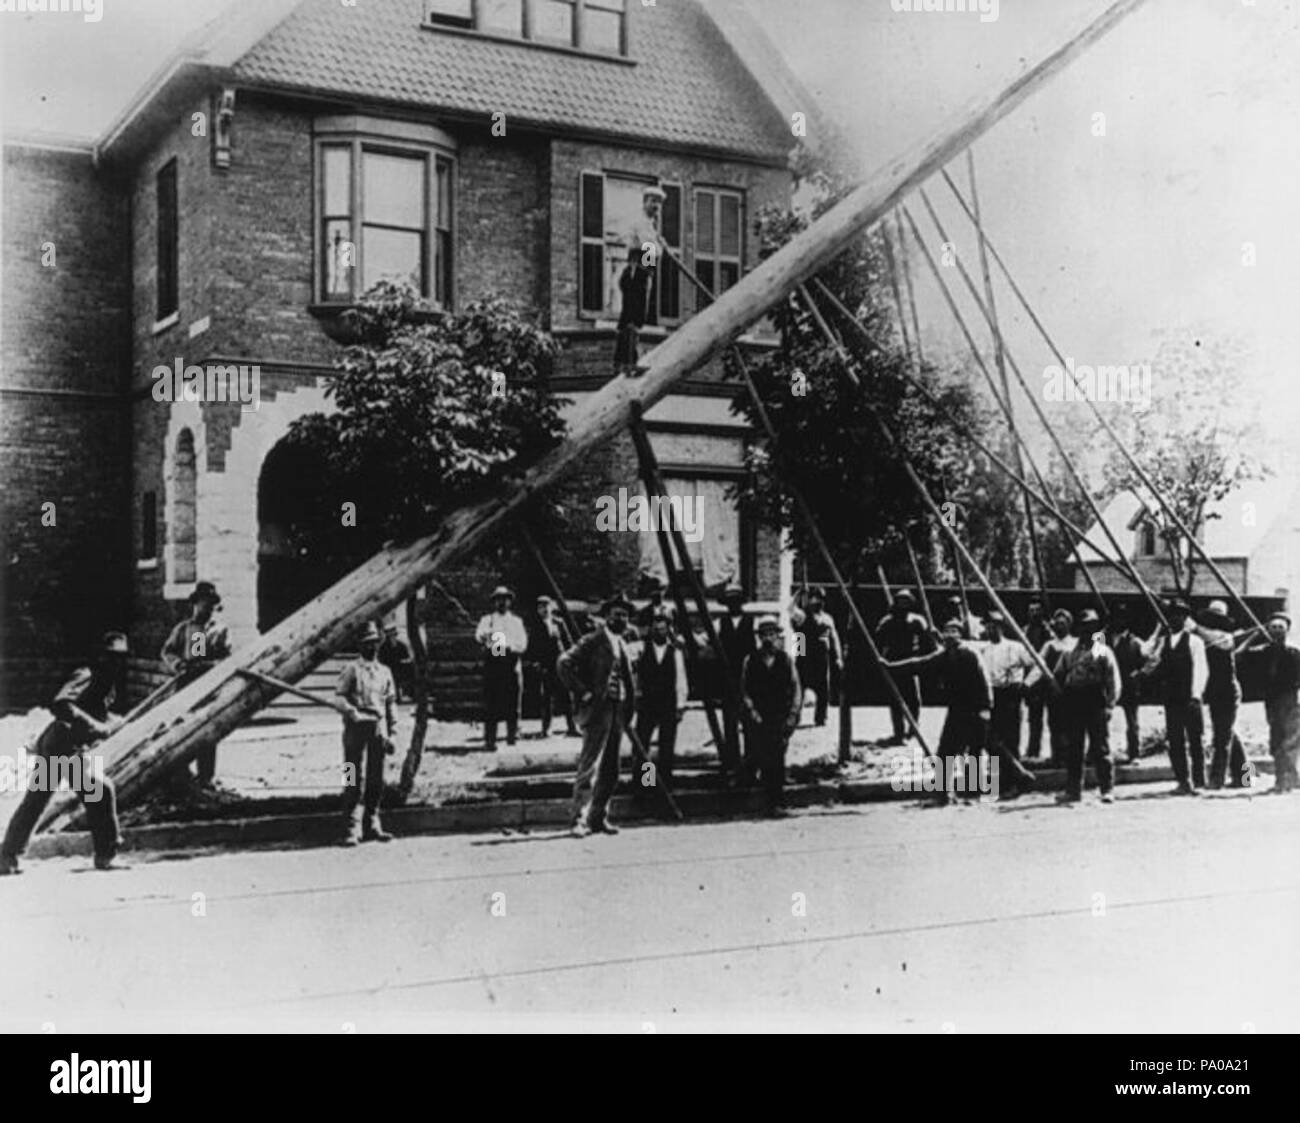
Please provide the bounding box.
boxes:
[1074,478,1300,610]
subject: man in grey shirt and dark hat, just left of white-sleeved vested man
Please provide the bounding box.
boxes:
[1053,608,1119,803]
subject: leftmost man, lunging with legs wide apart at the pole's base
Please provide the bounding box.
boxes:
[0,632,127,876]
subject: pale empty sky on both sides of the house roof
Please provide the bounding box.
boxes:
[0,0,1300,457]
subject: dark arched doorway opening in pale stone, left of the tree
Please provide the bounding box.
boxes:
[257,437,358,632]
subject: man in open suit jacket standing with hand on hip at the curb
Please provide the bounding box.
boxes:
[556,595,637,838]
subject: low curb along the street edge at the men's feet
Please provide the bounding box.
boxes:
[27,759,1273,858]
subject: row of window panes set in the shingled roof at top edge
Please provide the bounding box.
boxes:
[425,0,628,55]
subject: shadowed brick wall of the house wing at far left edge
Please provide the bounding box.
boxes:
[0,146,130,708]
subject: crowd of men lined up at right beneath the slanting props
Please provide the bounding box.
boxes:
[875,590,1300,803]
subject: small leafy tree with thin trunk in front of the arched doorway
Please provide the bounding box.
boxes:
[286,282,567,779]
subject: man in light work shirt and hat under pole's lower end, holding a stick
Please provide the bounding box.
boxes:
[334,623,398,846]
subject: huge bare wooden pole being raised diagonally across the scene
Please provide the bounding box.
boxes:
[42,0,1145,829]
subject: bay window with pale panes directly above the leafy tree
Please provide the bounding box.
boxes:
[316,118,455,307]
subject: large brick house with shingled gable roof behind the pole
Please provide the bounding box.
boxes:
[0,0,794,706]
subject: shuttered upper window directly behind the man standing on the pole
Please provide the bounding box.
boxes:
[579,172,683,324]
